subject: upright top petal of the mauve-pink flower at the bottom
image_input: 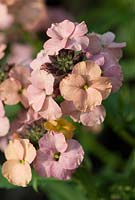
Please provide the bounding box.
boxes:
[54,133,68,153]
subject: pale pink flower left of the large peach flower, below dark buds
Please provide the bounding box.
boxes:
[27,69,61,120]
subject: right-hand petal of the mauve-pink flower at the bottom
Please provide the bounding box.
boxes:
[59,139,84,170]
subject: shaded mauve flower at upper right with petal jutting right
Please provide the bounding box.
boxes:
[88,32,126,59]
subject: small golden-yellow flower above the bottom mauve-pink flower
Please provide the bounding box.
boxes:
[45,118,75,139]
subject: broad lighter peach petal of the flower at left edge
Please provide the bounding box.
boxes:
[0,78,21,105]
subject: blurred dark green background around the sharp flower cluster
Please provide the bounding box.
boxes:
[0,0,135,200]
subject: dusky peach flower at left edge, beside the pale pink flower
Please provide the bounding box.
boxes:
[0,66,30,107]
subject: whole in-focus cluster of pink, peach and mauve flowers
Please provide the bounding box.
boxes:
[0,20,125,186]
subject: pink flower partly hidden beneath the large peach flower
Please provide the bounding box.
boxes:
[61,101,106,127]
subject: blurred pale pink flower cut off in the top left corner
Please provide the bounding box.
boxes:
[0,3,14,30]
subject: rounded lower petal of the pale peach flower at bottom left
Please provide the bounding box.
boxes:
[2,160,32,187]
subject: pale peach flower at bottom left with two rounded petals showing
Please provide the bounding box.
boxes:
[2,139,36,187]
